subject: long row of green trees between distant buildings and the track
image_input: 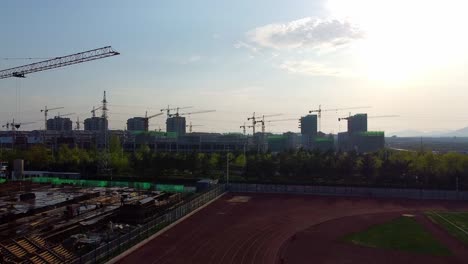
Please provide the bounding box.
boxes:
[0,138,468,190]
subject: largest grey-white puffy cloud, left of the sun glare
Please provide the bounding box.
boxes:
[249,17,364,50]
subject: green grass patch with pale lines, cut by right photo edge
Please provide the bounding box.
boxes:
[426,212,468,245]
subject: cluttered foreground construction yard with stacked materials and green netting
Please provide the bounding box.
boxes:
[0,177,211,263]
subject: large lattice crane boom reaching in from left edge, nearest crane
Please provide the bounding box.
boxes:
[0,46,120,79]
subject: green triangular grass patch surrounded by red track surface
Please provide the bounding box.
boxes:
[344,216,451,256]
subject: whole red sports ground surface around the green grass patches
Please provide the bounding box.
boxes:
[118,193,468,264]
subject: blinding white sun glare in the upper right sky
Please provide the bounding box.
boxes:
[327,0,468,82]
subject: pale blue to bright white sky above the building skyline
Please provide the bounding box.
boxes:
[0,0,468,133]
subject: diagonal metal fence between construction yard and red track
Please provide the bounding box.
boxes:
[71,185,225,264]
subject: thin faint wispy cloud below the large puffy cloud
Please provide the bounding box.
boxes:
[279,60,350,77]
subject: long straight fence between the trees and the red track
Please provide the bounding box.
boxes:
[228,183,468,200]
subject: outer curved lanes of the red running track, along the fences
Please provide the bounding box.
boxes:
[118,193,468,264]
